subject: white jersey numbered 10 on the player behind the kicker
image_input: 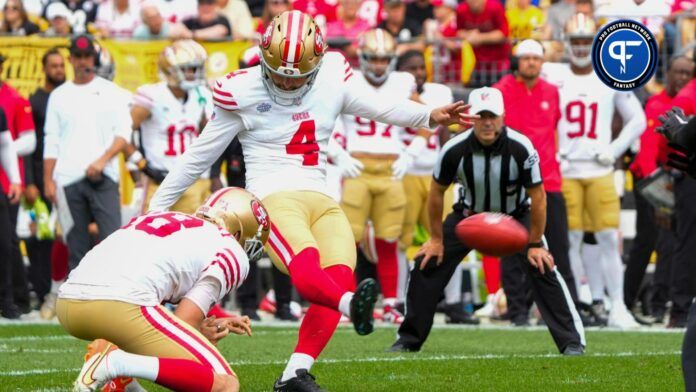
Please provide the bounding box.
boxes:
[133,82,213,178]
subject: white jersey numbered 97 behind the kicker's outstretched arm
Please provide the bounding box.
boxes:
[341,70,416,155]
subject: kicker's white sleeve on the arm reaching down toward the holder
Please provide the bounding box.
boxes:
[150,108,244,211]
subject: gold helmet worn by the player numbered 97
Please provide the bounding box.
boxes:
[358,29,396,84]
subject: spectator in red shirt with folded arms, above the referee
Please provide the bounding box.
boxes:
[457,0,510,87]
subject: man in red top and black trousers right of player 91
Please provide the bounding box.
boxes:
[624,56,694,322]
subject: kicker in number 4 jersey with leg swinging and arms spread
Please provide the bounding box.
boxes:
[150,11,475,391]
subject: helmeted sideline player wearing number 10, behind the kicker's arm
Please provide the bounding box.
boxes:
[128,40,213,214]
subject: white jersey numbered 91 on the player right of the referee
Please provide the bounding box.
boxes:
[541,63,645,178]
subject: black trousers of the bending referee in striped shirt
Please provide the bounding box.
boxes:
[398,211,585,352]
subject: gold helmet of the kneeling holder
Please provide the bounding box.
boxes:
[196,187,271,261]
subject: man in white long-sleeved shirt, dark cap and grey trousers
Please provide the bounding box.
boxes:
[44,35,131,269]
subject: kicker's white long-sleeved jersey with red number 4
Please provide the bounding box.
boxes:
[150,52,432,210]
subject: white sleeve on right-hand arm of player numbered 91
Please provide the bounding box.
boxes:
[610,92,647,158]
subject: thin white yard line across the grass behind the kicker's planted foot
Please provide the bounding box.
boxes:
[0,351,681,377]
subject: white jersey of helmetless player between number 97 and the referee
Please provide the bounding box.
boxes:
[402,83,454,176]
